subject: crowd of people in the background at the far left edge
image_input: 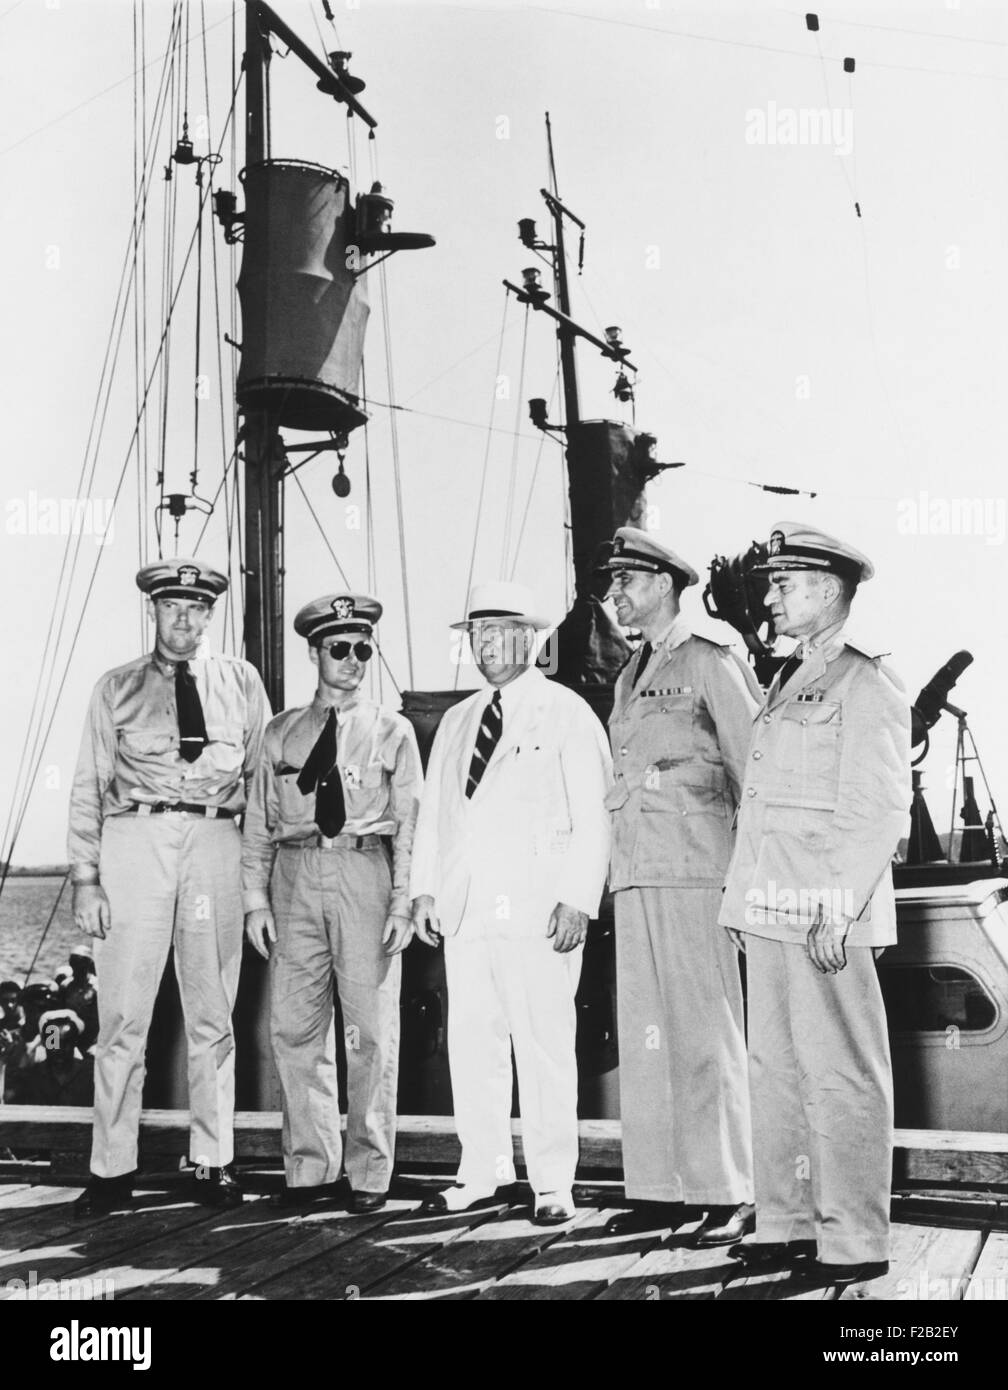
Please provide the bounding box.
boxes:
[0,941,99,1105]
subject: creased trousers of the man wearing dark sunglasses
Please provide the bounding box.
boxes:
[270,844,402,1193]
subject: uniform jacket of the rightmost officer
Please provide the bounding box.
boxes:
[719,631,912,947]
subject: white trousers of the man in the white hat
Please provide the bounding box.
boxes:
[445,922,583,1193]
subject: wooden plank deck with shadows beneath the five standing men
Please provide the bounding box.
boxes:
[0,1172,1008,1302]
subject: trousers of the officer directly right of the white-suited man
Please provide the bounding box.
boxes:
[615,888,752,1205]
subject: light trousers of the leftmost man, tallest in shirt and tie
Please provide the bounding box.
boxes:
[90,815,242,1177]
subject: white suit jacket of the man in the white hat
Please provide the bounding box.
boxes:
[410,667,612,937]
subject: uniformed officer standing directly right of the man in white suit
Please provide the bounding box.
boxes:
[608,527,759,1245]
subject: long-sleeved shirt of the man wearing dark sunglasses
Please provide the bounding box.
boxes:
[242,695,424,913]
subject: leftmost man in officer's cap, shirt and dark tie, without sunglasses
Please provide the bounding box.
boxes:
[68,559,270,1216]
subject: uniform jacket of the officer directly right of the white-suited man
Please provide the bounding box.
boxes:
[606,631,761,891]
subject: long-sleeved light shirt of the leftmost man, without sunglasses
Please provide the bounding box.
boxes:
[68,653,270,883]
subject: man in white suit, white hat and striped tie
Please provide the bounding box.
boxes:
[410,582,610,1225]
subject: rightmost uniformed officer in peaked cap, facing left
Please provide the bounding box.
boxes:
[720,521,911,1286]
